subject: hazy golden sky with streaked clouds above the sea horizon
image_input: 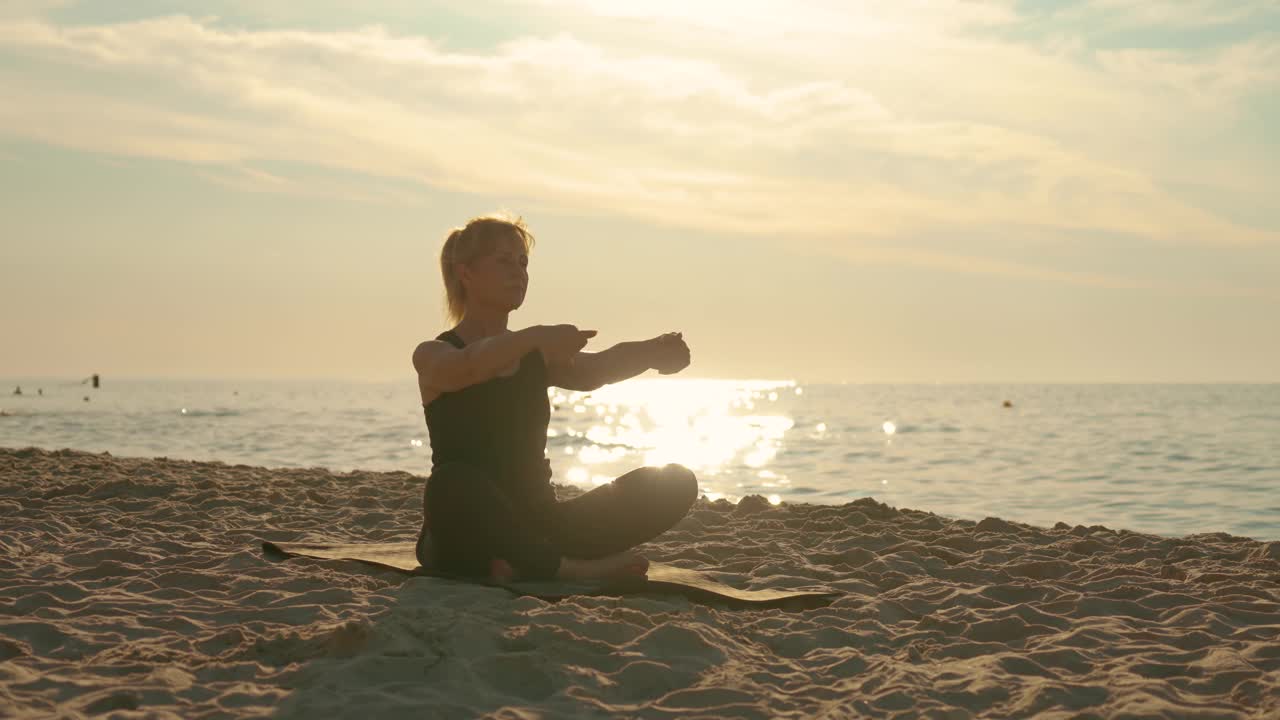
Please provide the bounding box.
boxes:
[0,0,1280,383]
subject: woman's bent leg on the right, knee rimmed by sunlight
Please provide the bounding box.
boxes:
[548,464,698,559]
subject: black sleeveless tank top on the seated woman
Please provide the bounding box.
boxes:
[422,331,556,506]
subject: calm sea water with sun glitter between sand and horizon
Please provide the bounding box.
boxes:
[0,378,1280,541]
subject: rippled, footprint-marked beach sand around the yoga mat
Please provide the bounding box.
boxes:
[0,448,1280,720]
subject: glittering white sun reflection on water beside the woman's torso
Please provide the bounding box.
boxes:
[547,378,800,502]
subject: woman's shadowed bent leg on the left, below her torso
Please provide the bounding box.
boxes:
[419,462,561,579]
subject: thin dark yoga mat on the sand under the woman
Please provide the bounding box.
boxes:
[262,541,841,609]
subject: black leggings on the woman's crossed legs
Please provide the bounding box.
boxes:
[417,462,698,580]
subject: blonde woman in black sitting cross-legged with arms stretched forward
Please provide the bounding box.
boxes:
[413,217,698,580]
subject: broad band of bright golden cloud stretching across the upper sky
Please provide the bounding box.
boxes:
[0,0,1276,279]
